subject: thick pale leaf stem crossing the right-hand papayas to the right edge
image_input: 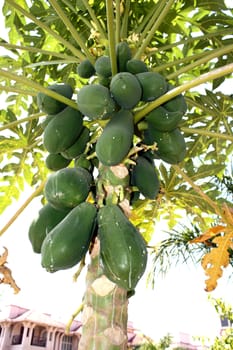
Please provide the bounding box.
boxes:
[134,63,233,124]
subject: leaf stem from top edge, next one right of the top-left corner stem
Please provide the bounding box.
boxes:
[49,0,94,63]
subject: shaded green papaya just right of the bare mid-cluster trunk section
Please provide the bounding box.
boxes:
[131,156,160,199]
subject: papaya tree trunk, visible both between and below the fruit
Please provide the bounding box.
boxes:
[78,164,129,350]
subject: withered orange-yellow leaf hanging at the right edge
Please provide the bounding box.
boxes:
[201,231,233,292]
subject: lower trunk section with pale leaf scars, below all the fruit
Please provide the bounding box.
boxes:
[78,239,128,350]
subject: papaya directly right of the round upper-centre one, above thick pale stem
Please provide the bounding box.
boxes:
[135,72,167,102]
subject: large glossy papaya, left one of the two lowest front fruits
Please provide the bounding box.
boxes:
[41,202,96,272]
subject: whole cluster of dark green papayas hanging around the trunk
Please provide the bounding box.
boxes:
[29,42,186,290]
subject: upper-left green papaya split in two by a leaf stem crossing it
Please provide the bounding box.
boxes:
[37,84,73,114]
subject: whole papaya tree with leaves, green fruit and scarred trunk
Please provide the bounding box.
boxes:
[0,0,233,350]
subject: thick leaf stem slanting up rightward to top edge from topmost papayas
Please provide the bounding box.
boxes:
[134,0,174,59]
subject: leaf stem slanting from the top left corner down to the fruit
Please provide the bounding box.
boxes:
[6,0,85,60]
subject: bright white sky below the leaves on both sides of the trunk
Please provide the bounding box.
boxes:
[0,0,233,340]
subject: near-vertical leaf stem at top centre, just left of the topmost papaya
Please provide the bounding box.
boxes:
[106,0,117,75]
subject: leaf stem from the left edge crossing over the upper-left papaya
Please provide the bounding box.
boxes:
[0,69,78,109]
